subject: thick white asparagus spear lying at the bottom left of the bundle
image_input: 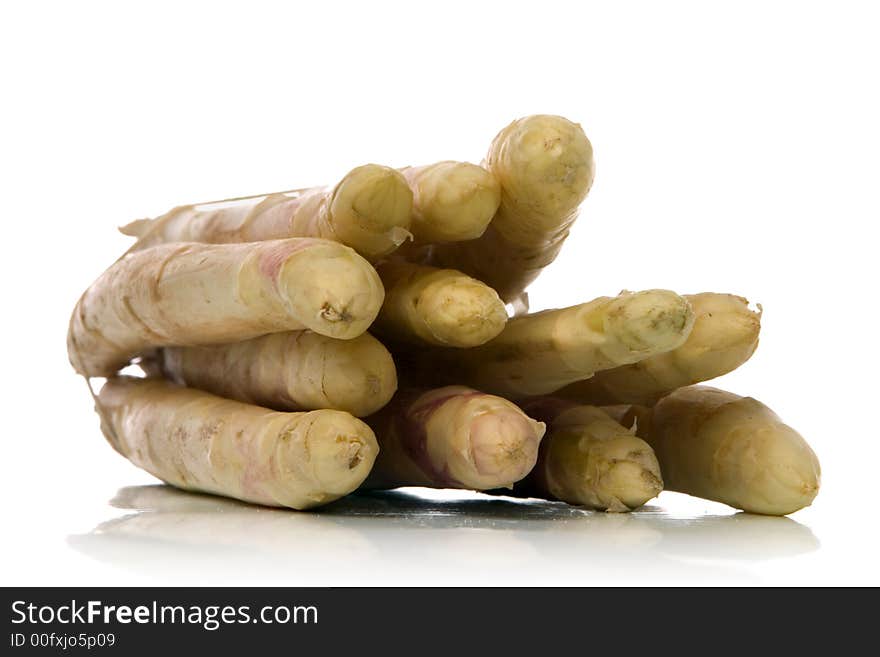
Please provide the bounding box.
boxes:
[96,377,378,509]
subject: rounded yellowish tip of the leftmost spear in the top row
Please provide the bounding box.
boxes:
[330,164,413,258]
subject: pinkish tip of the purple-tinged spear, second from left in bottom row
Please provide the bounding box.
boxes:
[470,408,546,486]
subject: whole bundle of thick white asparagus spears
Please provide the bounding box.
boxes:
[68,115,819,515]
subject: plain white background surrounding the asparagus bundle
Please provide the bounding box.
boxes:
[0,0,880,585]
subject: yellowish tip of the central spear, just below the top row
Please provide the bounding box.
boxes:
[419,276,507,348]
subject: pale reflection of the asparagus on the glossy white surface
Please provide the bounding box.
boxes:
[68,486,820,586]
